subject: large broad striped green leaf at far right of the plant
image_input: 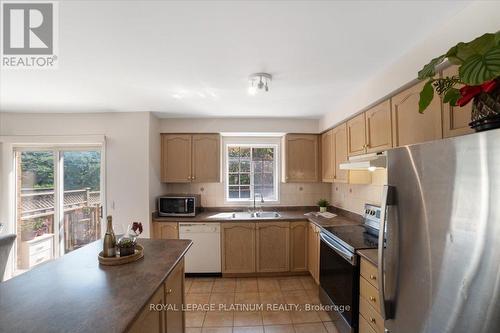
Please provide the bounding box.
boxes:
[459,46,500,86]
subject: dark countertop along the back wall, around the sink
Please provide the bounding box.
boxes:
[153,207,361,227]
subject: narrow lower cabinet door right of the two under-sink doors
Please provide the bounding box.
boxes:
[290,221,309,272]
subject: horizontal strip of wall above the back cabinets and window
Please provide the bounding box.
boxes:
[160,118,318,133]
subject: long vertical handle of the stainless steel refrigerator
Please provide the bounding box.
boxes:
[377,185,396,319]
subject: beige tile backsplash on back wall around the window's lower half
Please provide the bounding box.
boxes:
[163,183,332,207]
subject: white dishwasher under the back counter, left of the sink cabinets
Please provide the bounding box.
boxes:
[179,222,221,273]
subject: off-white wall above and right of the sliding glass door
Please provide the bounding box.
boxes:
[0,112,154,237]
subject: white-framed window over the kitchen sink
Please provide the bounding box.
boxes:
[224,138,279,203]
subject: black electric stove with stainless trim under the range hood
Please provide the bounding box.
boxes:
[319,204,381,332]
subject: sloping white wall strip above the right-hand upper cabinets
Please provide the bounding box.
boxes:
[319,1,500,131]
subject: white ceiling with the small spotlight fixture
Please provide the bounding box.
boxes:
[0,0,468,118]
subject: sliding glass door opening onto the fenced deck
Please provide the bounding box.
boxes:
[15,147,104,274]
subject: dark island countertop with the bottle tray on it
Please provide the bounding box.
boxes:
[0,239,192,332]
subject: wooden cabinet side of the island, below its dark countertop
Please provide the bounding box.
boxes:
[128,259,185,333]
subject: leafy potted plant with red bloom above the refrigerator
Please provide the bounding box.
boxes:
[418,32,500,132]
